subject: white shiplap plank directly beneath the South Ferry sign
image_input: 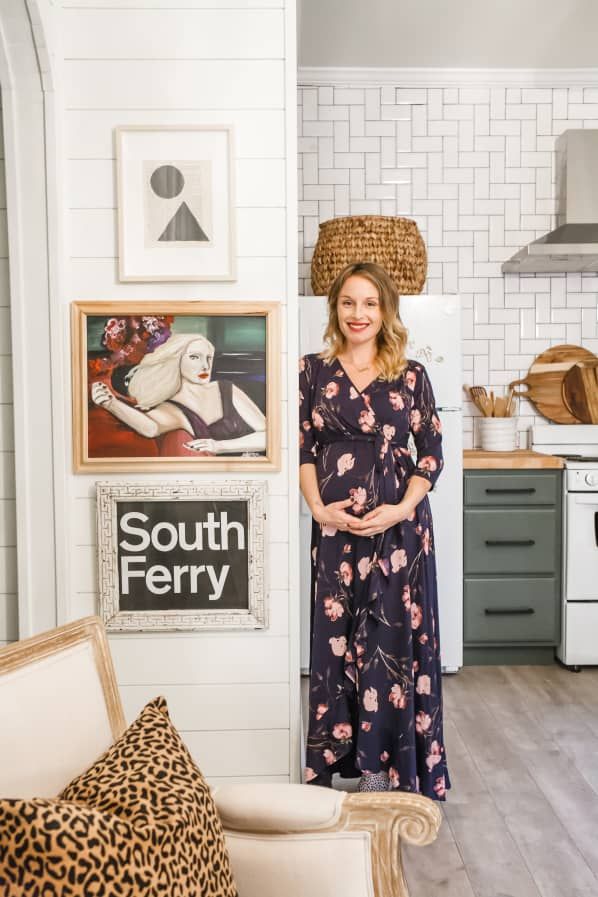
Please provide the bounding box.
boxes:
[110,632,288,688]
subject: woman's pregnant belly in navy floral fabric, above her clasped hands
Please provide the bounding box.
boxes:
[316,442,379,516]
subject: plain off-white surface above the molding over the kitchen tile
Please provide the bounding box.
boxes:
[299,0,598,68]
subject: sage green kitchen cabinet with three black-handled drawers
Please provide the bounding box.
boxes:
[463,470,562,665]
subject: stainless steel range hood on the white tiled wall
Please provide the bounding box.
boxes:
[502,129,598,274]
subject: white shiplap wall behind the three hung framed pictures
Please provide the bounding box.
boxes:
[60,0,298,782]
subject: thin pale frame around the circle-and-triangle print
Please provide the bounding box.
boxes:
[114,124,237,283]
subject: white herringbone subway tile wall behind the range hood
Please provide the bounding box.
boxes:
[299,78,598,448]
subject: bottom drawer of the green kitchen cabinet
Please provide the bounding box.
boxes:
[463,577,560,644]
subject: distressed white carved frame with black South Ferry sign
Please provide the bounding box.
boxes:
[96,480,268,632]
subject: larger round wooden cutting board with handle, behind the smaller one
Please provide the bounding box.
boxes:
[509,345,598,424]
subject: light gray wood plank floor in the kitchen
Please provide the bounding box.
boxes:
[304,665,598,897]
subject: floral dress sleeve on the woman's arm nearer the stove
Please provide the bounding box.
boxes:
[409,364,444,489]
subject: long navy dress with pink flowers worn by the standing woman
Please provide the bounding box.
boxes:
[299,355,450,800]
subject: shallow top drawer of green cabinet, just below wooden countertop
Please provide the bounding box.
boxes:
[464,472,560,506]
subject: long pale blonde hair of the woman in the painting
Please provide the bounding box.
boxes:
[128,333,214,411]
